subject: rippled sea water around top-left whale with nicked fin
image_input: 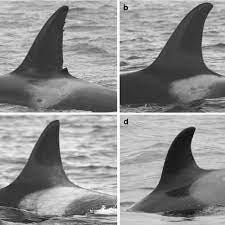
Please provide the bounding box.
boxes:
[0,0,117,112]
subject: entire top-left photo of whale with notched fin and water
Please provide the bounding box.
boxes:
[0,0,117,112]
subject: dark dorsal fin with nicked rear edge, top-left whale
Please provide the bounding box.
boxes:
[14,6,69,74]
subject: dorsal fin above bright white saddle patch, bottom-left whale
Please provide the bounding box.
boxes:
[10,120,72,190]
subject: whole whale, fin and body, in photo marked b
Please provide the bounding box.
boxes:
[120,3,225,105]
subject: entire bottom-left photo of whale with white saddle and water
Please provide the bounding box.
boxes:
[0,114,117,225]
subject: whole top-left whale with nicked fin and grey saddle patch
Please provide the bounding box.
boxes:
[0,6,117,112]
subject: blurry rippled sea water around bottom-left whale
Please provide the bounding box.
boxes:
[0,116,117,225]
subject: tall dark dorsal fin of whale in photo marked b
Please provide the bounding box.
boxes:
[146,3,214,80]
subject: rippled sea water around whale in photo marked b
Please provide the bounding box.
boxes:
[120,0,225,112]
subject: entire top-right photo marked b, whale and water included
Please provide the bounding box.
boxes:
[120,0,225,113]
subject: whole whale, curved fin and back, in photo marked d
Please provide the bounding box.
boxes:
[130,127,225,215]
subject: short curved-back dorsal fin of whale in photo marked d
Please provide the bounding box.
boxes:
[155,127,208,191]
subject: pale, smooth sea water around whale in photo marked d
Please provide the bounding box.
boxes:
[120,115,225,225]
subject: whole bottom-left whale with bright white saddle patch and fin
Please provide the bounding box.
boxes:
[0,121,116,218]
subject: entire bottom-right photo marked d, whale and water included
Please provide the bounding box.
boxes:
[120,114,225,225]
